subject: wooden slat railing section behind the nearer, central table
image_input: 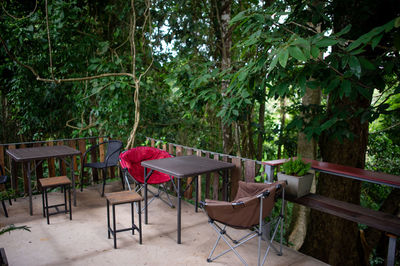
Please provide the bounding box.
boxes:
[146,137,266,199]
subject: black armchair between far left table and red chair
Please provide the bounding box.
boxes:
[80,140,125,197]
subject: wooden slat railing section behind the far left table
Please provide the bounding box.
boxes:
[0,137,110,194]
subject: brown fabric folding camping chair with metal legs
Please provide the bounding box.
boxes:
[204,181,286,265]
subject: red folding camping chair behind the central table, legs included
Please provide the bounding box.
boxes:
[119,146,174,211]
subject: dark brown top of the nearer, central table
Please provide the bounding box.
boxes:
[141,155,235,178]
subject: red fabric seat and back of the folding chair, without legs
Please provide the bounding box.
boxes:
[119,146,172,184]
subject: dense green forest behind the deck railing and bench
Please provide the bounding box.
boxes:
[0,0,400,265]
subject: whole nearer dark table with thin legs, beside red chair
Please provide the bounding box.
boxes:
[141,155,235,244]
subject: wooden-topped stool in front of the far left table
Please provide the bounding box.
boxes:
[39,176,72,224]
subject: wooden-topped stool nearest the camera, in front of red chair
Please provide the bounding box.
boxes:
[105,190,143,248]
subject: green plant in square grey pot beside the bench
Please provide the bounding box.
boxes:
[278,157,314,198]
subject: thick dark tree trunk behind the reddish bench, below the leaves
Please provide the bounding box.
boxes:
[300,95,370,265]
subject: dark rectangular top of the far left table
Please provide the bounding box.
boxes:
[7,146,81,162]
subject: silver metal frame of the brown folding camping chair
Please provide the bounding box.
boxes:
[203,185,285,266]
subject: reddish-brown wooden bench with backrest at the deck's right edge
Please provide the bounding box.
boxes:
[264,158,400,265]
